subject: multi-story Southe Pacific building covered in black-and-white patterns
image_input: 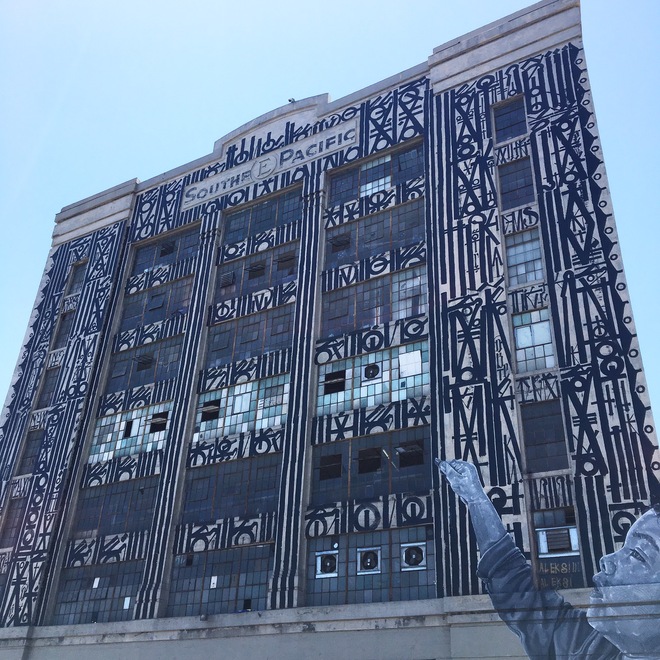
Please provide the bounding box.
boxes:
[0,0,660,658]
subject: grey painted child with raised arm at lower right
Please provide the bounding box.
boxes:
[438,460,660,659]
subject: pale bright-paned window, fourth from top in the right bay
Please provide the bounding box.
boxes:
[513,308,555,373]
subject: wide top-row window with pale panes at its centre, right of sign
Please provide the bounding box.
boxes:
[328,144,424,206]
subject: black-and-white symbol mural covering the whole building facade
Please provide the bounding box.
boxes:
[0,34,660,625]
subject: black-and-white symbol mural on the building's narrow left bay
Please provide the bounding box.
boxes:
[2,224,123,625]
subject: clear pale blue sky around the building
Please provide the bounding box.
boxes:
[0,0,660,422]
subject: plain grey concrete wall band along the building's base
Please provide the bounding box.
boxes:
[0,589,600,660]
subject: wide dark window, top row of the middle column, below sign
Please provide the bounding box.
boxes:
[222,188,303,244]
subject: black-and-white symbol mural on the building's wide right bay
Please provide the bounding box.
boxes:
[429,45,660,594]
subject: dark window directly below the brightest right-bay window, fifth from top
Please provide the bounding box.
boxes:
[521,400,568,472]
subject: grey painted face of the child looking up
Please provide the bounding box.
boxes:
[587,511,660,654]
